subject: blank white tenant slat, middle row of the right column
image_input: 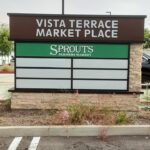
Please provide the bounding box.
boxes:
[73,69,128,79]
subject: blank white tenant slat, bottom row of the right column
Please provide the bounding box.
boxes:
[73,80,127,90]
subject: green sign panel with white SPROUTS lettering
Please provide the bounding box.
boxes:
[16,43,128,58]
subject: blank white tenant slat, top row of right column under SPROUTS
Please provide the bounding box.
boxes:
[73,59,128,69]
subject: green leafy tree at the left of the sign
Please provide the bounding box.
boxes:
[0,24,13,63]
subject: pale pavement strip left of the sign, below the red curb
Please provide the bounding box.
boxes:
[0,74,14,100]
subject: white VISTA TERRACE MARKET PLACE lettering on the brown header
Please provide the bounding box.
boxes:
[36,19,118,38]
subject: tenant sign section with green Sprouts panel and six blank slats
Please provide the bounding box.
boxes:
[15,42,129,91]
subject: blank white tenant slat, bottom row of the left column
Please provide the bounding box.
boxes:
[16,79,71,89]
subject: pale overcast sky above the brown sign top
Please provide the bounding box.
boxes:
[0,0,150,29]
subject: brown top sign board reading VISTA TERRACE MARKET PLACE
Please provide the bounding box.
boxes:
[8,14,145,43]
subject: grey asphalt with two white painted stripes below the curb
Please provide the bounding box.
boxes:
[0,136,150,150]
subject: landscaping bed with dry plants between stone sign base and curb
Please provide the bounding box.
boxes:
[0,101,150,126]
